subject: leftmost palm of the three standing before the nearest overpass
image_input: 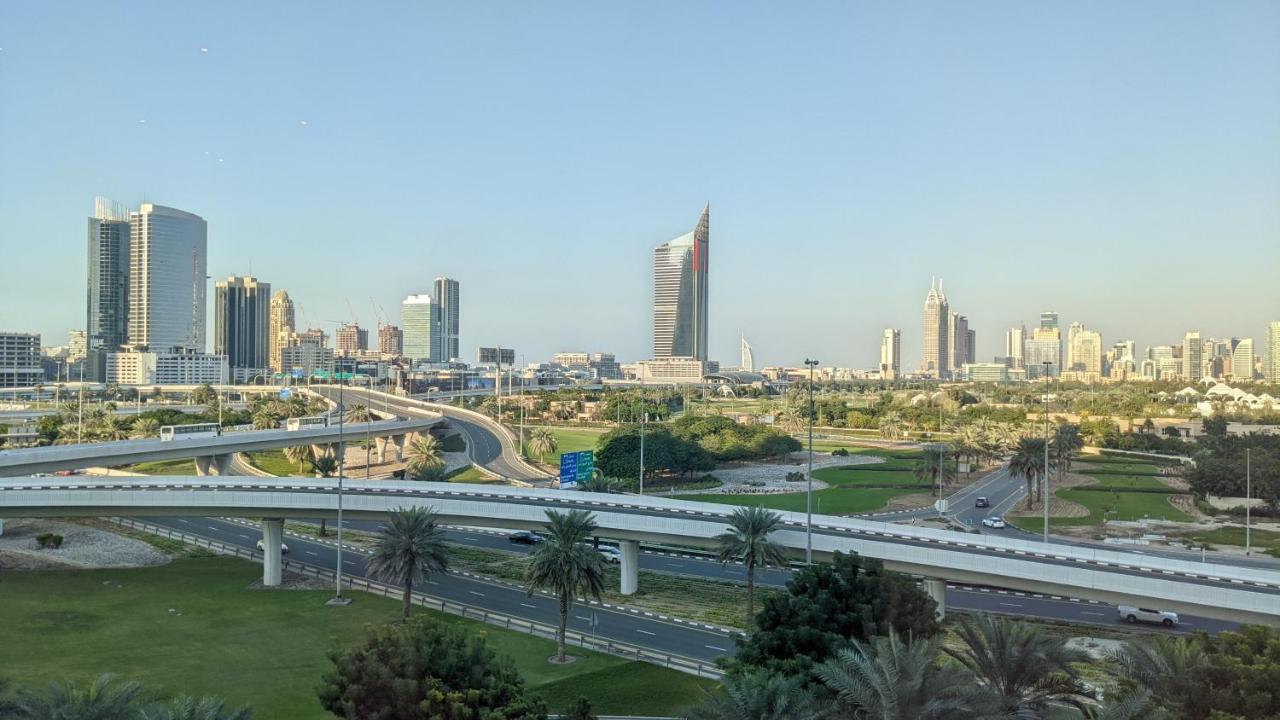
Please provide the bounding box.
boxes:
[366,507,449,621]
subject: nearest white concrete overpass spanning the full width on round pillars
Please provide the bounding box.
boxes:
[0,477,1280,624]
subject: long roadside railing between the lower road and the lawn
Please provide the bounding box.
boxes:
[110,518,724,680]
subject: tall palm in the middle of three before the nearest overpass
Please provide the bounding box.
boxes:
[525,510,604,662]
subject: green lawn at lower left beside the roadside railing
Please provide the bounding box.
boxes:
[0,557,710,719]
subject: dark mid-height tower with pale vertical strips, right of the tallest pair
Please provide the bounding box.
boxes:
[214,275,271,371]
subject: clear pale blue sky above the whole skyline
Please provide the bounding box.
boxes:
[0,0,1280,368]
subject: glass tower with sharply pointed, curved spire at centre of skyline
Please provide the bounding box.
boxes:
[653,205,710,360]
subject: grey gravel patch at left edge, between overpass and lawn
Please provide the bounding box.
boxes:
[0,519,169,569]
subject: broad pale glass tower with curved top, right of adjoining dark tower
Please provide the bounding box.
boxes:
[129,202,209,352]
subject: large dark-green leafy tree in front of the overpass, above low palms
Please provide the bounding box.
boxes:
[730,552,938,676]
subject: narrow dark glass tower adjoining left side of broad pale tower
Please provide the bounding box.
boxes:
[84,197,131,382]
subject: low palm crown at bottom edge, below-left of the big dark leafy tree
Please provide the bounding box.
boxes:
[689,670,819,720]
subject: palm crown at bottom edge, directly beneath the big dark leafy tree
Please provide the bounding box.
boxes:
[814,633,979,720]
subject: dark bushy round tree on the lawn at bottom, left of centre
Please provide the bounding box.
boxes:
[316,619,547,720]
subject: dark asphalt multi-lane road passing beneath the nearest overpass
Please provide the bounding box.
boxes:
[146,518,1235,661]
